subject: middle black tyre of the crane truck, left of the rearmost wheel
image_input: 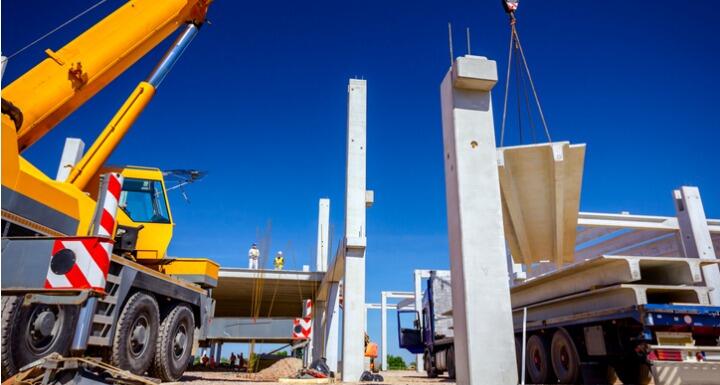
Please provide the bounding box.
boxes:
[111,292,160,375]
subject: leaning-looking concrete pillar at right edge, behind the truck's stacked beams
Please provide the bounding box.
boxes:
[673,186,720,306]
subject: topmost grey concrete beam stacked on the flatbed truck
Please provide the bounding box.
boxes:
[510,255,720,308]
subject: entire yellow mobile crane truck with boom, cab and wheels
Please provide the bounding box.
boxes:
[1,0,218,381]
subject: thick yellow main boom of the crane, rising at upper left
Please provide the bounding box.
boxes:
[2,0,211,152]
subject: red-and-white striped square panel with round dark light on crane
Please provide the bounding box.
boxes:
[45,237,113,291]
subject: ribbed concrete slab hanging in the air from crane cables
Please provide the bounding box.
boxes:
[498,142,585,266]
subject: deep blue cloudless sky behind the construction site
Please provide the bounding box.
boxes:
[1,0,720,360]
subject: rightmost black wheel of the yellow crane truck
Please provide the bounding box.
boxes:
[151,305,195,382]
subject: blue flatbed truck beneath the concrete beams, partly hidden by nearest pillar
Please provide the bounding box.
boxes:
[398,272,720,385]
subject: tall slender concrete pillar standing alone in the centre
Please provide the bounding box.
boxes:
[342,79,367,382]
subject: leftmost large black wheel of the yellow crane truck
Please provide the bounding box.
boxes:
[2,296,78,379]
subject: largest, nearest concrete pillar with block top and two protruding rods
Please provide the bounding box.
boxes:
[441,55,518,385]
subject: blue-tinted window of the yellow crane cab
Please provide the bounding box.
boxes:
[120,178,170,223]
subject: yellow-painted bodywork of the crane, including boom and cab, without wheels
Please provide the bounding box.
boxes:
[2,0,217,280]
